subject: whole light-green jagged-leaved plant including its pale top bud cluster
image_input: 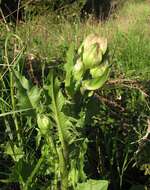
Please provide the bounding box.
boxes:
[1,35,110,190]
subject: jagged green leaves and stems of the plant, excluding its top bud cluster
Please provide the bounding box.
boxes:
[0,33,109,190]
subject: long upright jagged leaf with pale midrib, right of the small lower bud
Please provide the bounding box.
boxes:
[48,73,79,144]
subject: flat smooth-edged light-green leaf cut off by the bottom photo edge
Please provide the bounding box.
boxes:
[76,179,108,190]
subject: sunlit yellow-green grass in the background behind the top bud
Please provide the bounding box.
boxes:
[8,1,150,80]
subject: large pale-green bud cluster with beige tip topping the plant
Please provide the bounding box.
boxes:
[69,34,110,93]
